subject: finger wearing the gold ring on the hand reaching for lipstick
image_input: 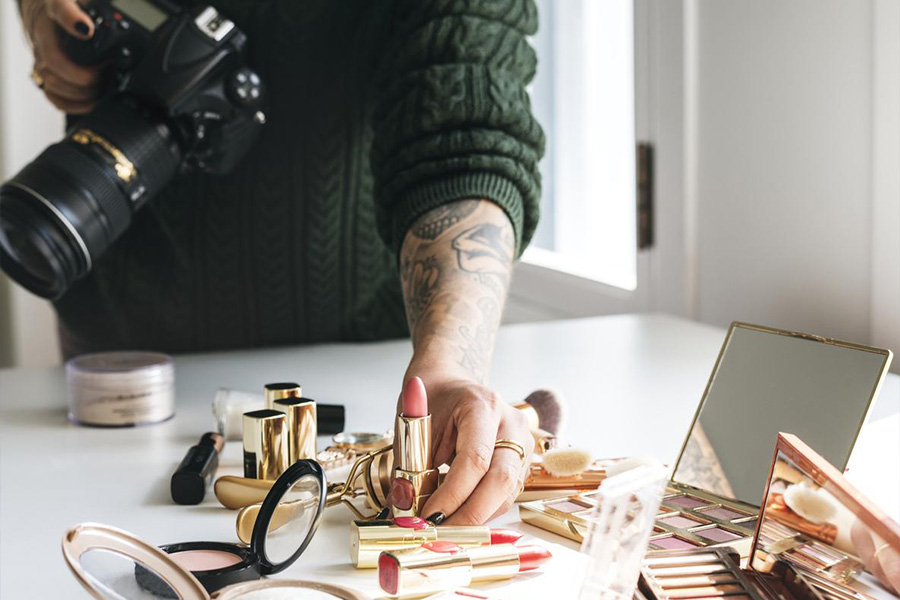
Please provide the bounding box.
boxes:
[447,414,527,525]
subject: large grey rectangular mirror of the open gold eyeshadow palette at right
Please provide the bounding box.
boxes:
[673,325,886,505]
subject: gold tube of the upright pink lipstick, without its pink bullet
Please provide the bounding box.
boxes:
[392,415,438,517]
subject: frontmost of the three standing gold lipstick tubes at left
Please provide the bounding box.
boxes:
[244,409,288,480]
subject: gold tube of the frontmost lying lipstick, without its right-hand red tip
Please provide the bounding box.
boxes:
[385,544,519,598]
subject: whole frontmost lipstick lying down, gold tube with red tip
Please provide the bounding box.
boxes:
[378,541,550,598]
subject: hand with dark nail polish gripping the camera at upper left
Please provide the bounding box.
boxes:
[22,0,100,115]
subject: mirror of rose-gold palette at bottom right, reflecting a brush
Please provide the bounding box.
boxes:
[751,451,900,598]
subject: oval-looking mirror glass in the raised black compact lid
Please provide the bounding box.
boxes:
[265,475,321,564]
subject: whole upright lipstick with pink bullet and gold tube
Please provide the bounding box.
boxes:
[390,377,438,517]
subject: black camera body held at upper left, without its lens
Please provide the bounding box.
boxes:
[63,0,265,174]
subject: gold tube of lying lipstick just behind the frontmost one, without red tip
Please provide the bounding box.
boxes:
[350,520,491,569]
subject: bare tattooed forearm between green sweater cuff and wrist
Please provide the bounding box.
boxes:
[400,200,515,381]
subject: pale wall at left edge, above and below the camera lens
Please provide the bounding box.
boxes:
[0,1,64,367]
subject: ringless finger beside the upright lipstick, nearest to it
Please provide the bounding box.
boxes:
[423,397,501,515]
